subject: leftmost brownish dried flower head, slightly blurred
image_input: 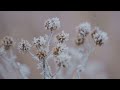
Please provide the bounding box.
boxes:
[1,36,14,50]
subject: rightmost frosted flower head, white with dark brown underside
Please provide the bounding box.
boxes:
[91,27,108,46]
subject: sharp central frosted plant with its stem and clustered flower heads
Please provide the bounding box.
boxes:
[18,17,71,78]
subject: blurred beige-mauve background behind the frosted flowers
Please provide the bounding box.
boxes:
[0,11,120,79]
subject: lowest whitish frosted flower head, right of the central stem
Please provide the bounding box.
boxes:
[55,53,71,68]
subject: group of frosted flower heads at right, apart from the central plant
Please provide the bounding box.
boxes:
[75,23,108,46]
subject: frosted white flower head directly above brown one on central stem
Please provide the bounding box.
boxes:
[33,35,48,50]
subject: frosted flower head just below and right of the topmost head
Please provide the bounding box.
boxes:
[55,31,69,43]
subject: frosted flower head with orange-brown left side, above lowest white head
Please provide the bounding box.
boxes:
[53,43,68,56]
